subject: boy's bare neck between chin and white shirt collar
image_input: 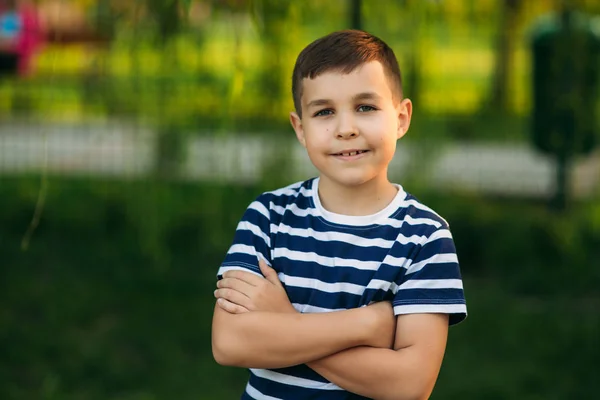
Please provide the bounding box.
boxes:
[318,176,398,216]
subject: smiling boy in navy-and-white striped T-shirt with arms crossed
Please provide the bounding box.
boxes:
[212,30,466,400]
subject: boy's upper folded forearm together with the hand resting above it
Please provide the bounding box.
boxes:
[212,261,395,368]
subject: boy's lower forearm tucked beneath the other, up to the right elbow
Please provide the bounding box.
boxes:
[307,346,438,400]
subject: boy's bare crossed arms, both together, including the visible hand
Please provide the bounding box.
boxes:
[212,261,448,400]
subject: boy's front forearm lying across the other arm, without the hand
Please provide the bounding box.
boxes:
[212,307,373,368]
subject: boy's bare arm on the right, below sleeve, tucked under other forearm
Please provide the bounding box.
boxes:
[308,314,448,400]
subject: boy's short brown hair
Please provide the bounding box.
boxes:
[292,30,402,117]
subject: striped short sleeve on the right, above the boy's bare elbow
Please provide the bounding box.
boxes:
[393,226,467,325]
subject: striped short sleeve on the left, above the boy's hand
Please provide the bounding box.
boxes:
[217,195,271,279]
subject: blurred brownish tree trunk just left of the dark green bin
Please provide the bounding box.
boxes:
[489,0,523,112]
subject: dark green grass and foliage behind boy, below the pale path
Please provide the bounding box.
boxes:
[0,177,600,400]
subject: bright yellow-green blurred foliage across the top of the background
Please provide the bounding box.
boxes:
[5,0,556,131]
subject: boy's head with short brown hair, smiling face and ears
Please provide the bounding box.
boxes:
[290,30,412,187]
